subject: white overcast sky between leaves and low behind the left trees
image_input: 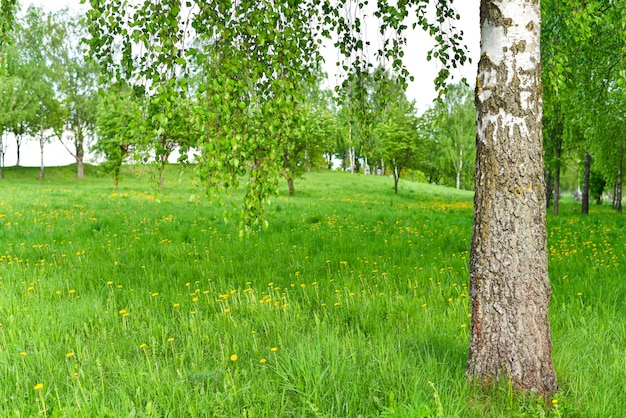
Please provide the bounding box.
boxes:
[11,0,480,166]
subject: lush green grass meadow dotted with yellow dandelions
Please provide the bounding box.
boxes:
[0,166,626,417]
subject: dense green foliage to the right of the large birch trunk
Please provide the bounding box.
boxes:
[541,0,626,209]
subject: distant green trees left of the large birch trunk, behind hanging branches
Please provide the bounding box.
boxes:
[0,2,475,194]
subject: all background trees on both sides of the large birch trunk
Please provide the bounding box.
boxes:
[0,0,626,219]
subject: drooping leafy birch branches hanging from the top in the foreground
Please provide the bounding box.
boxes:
[87,0,466,231]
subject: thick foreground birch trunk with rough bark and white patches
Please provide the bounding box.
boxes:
[467,0,558,398]
